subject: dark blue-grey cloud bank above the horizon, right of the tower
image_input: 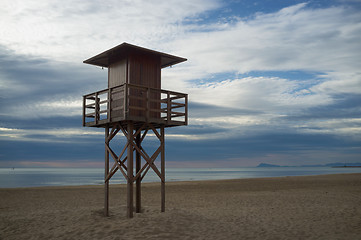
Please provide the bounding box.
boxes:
[166,131,361,167]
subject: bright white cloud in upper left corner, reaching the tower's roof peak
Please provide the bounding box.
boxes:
[0,0,219,62]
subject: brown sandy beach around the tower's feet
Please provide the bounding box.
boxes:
[0,174,361,239]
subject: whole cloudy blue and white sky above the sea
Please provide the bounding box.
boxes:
[0,0,361,167]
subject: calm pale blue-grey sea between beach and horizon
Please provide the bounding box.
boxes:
[0,167,361,188]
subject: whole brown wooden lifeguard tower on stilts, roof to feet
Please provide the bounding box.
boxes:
[83,43,188,218]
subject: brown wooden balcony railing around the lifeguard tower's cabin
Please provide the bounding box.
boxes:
[83,84,188,126]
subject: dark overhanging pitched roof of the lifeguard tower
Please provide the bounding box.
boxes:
[83,42,187,68]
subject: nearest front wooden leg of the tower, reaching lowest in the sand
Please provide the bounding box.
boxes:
[127,123,134,218]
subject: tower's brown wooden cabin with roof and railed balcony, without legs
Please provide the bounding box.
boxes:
[83,43,188,127]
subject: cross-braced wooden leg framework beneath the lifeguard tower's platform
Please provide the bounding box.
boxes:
[104,121,165,218]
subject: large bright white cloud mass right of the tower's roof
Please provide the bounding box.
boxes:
[164,3,361,109]
